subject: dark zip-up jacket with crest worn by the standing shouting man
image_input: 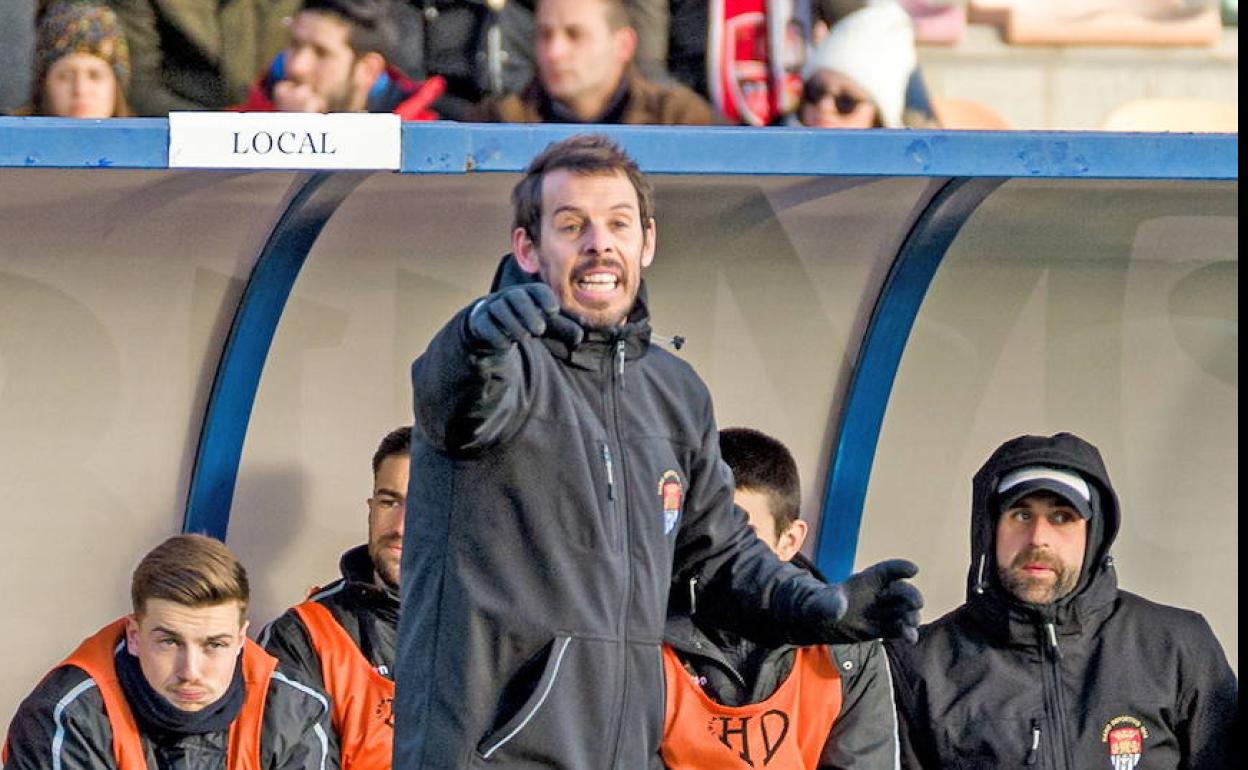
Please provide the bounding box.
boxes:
[394,257,833,770]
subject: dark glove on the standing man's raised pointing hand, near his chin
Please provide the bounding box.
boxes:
[468,283,583,352]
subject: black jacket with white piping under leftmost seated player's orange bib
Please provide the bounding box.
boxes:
[4,646,338,770]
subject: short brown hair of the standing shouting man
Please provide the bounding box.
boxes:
[512,134,654,243]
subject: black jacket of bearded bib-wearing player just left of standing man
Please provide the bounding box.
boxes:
[260,545,398,690]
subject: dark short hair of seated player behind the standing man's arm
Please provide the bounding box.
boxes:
[719,428,801,534]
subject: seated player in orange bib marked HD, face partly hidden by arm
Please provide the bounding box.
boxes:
[661,428,897,770]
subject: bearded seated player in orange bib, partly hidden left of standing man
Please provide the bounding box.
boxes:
[260,427,412,770]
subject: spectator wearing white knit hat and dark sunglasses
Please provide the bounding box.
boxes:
[797,1,919,129]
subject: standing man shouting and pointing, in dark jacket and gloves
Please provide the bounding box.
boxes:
[394,136,921,770]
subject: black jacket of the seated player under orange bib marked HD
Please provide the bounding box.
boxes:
[664,554,899,770]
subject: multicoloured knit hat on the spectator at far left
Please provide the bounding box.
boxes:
[35,0,130,91]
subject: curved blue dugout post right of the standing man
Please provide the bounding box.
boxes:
[815,177,1003,580]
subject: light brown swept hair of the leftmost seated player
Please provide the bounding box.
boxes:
[130,534,251,615]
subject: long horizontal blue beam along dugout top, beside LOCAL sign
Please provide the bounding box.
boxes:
[0,117,1239,180]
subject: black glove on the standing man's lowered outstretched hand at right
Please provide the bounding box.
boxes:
[836,559,924,644]
